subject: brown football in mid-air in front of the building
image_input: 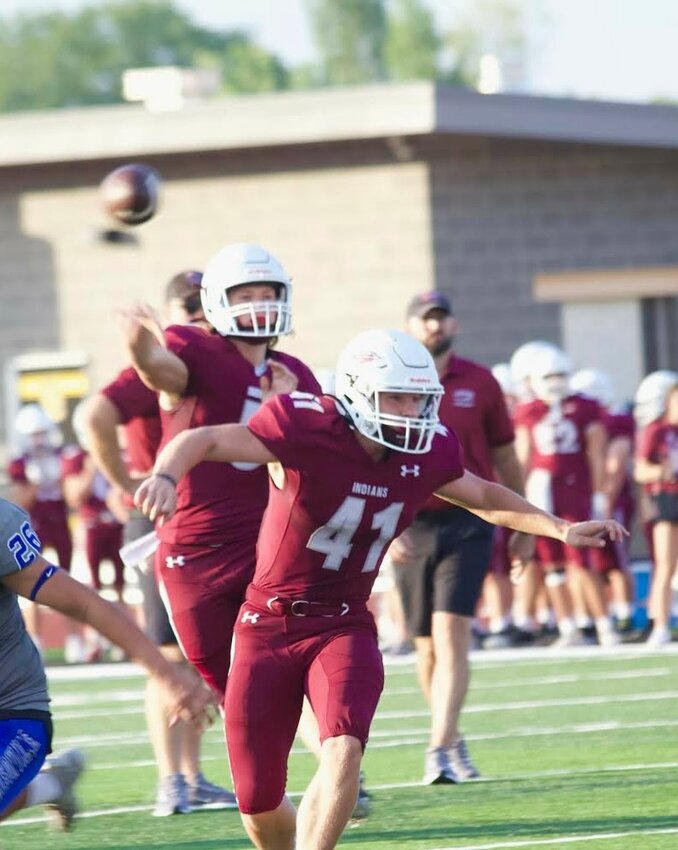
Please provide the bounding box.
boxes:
[101,163,160,225]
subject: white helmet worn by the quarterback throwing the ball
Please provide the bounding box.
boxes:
[200,242,292,339]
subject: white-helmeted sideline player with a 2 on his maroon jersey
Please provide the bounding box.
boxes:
[515,348,619,645]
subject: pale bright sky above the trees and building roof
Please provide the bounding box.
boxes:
[5,0,678,102]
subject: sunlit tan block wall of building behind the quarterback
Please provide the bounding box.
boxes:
[0,143,433,444]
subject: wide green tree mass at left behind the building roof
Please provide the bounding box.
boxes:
[0,0,287,111]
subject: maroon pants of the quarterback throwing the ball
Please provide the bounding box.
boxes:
[155,540,255,695]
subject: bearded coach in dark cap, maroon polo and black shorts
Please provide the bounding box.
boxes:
[390,292,523,784]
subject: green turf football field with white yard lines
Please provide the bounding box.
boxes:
[0,644,678,850]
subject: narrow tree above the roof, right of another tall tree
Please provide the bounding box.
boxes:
[384,0,442,80]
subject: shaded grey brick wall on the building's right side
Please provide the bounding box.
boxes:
[427,138,678,366]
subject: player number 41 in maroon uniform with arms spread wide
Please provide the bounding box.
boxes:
[136,331,626,850]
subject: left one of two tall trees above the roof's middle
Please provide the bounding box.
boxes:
[306,0,387,85]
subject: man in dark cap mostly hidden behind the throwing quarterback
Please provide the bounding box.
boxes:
[83,270,236,817]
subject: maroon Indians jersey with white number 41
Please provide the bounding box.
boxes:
[248,393,464,604]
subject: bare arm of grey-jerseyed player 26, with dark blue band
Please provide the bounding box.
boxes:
[2,556,216,726]
